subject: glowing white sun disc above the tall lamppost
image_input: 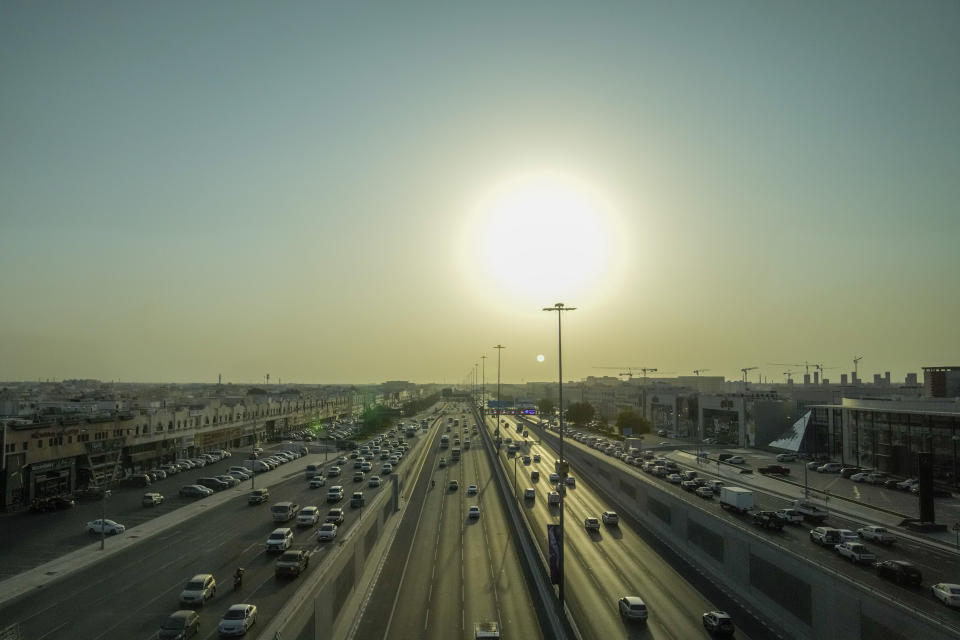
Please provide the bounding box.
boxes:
[471,173,615,301]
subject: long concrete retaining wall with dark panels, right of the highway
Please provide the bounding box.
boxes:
[538,422,960,640]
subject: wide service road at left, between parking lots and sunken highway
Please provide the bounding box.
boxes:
[0,412,436,640]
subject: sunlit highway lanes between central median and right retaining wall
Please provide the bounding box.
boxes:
[487,418,760,639]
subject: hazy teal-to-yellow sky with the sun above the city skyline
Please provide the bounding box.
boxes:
[0,0,960,382]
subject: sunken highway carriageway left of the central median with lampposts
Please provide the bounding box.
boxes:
[355,404,543,640]
